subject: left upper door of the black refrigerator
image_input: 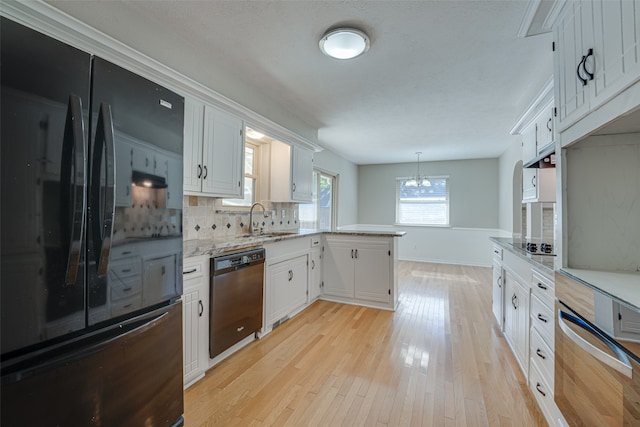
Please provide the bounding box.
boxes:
[0,18,91,358]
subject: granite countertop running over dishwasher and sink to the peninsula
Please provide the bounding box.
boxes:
[183,229,406,258]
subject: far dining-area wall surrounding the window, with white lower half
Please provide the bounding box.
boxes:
[358,159,499,266]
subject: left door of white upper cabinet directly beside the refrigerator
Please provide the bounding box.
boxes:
[183,98,204,192]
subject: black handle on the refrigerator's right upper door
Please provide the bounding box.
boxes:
[91,103,116,276]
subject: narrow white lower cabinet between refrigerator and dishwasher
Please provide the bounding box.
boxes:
[182,256,209,388]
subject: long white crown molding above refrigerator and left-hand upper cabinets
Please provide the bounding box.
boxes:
[0,0,322,152]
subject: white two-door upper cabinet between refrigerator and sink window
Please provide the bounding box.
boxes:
[184,98,244,197]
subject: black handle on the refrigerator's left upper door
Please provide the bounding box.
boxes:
[60,95,87,286]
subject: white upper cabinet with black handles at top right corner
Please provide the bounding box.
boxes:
[554,0,640,132]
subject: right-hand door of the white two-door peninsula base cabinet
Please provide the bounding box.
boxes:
[354,238,391,303]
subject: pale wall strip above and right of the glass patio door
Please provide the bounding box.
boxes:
[313,150,358,227]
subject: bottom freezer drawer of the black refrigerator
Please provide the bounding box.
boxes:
[0,301,183,427]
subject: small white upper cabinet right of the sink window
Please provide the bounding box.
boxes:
[269,141,313,203]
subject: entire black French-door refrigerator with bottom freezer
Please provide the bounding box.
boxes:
[0,17,184,426]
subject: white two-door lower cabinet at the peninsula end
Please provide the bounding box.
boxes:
[322,235,397,309]
